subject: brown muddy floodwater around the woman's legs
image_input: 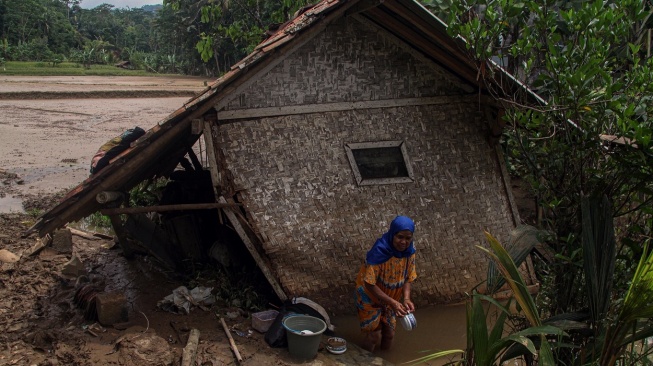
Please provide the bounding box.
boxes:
[332,304,466,365]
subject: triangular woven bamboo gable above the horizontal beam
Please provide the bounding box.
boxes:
[226,20,464,110]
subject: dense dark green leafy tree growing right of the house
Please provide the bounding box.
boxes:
[420,0,653,363]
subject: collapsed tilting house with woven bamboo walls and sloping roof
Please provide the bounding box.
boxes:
[29,0,532,313]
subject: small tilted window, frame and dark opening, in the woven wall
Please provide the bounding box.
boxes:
[345,141,413,185]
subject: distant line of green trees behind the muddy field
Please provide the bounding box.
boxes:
[0,0,307,76]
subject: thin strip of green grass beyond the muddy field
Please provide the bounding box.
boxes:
[0,61,183,76]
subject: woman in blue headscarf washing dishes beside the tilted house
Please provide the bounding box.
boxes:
[356,216,417,352]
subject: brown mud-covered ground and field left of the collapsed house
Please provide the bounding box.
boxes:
[0,76,384,365]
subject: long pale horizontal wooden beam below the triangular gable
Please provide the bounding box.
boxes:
[218,95,474,121]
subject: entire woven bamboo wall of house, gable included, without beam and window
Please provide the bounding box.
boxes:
[219,17,512,313]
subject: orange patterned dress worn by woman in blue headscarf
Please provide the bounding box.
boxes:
[356,254,417,332]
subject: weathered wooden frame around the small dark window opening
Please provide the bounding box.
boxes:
[345,140,415,186]
